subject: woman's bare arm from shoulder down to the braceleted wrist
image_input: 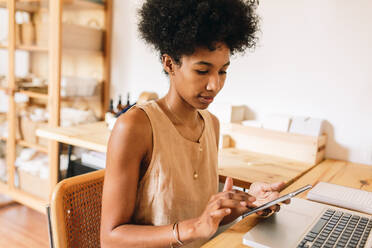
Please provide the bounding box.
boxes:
[101,108,201,247]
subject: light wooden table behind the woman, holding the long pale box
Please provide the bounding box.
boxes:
[37,122,313,188]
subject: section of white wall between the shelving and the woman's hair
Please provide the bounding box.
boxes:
[111,0,168,100]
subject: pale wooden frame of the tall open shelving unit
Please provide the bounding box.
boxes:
[0,0,112,212]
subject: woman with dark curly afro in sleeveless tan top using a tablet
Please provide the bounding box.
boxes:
[101,0,283,247]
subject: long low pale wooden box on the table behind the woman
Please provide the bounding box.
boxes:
[221,123,327,165]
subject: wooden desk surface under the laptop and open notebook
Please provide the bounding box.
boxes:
[203,159,372,248]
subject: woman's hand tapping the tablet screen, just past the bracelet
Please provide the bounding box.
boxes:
[189,178,256,239]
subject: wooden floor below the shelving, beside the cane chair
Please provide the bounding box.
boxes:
[0,195,49,248]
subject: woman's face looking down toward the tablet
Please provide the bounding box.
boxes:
[169,43,230,109]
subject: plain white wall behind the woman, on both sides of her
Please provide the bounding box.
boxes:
[111,0,372,165]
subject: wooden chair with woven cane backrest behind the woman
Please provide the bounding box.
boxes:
[47,170,105,248]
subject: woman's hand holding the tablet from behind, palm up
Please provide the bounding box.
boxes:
[249,182,290,216]
